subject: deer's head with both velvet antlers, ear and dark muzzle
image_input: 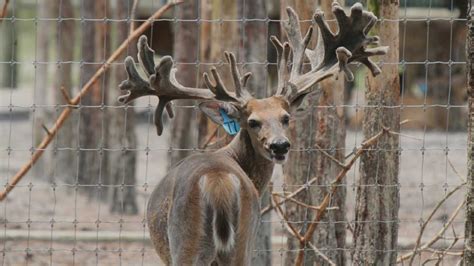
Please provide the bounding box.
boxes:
[119,3,388,163]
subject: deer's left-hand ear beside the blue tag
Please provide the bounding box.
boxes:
[199,101,240,125]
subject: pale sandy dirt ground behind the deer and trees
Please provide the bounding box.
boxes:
[0,119,467,265]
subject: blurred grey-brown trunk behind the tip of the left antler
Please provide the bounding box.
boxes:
[107,0,138,214]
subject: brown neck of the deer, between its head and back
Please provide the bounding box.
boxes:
[222,129,275,195]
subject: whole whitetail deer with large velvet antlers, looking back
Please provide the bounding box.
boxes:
[119,4,387,265]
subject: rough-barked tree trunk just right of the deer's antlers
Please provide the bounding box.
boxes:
[352,0,400,265]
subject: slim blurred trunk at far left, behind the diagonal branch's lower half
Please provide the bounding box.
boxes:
[51,0,78,184]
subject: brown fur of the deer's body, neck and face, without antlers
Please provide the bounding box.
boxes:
[147,97,289,265]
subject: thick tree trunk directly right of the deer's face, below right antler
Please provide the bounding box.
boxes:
[281,0,346,265]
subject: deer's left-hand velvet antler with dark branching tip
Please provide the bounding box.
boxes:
[118,36,260,135]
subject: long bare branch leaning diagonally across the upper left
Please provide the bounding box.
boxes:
[0,1,182,201]
